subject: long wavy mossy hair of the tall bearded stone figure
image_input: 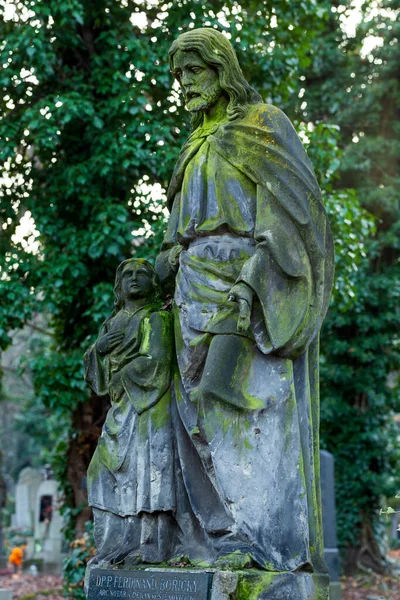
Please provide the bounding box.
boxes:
[169,27,262,129]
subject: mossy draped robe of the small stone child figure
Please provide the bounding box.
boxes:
[84,305,175,517]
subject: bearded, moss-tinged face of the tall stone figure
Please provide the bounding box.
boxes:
[173,50,222,112]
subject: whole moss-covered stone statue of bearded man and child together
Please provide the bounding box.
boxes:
[85,28,333,600]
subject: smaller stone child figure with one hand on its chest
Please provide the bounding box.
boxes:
[84,259,176,567]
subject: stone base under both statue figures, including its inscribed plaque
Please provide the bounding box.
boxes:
[87,565,329,600]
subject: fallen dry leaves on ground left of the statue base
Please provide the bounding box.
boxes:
[0,574,64,600]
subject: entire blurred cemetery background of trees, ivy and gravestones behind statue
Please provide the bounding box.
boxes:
[0,0,400,600]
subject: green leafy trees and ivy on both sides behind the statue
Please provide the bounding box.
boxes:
[0,0,400,580]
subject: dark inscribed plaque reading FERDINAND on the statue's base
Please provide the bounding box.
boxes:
[88,569,212,600]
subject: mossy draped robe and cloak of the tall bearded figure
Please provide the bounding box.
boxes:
[156,104,333,572]
